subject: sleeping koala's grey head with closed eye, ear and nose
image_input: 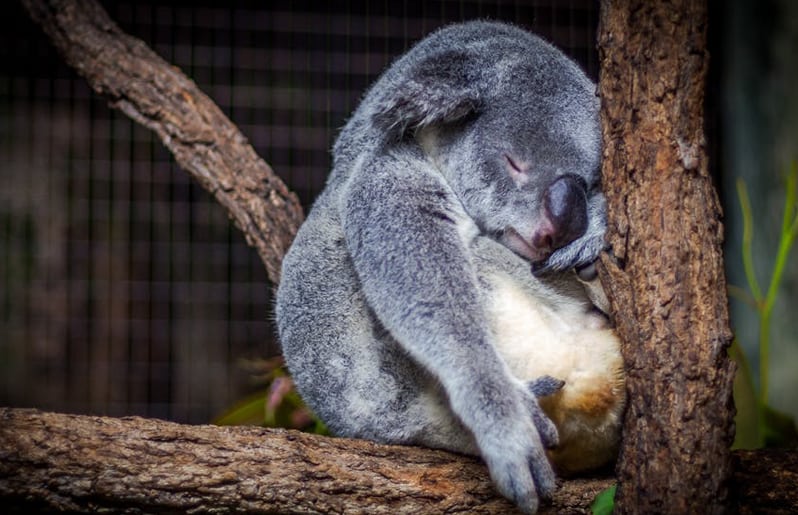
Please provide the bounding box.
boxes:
[374,22,603,270]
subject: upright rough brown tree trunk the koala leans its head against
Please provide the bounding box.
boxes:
[599,0,734,513]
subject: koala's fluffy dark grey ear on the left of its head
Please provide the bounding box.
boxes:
[374,50,480,139]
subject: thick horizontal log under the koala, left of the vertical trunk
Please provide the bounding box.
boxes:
[0,408,612,514]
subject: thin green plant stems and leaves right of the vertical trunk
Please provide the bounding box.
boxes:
[730,162,798,448]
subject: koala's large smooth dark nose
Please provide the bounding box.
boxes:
[544,175,587,250]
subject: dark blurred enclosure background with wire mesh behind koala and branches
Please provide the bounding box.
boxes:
[0,0,798,423]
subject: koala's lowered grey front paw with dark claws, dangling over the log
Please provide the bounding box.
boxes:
[479,394,558,513]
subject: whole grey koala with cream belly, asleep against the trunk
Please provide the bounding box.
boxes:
[276,21,624,513]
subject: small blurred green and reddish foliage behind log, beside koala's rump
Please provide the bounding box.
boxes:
[213,357,329,434]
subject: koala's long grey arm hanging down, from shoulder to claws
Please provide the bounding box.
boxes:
[340,150,557,511]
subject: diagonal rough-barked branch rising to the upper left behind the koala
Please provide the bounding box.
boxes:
[22,0,303,284]
